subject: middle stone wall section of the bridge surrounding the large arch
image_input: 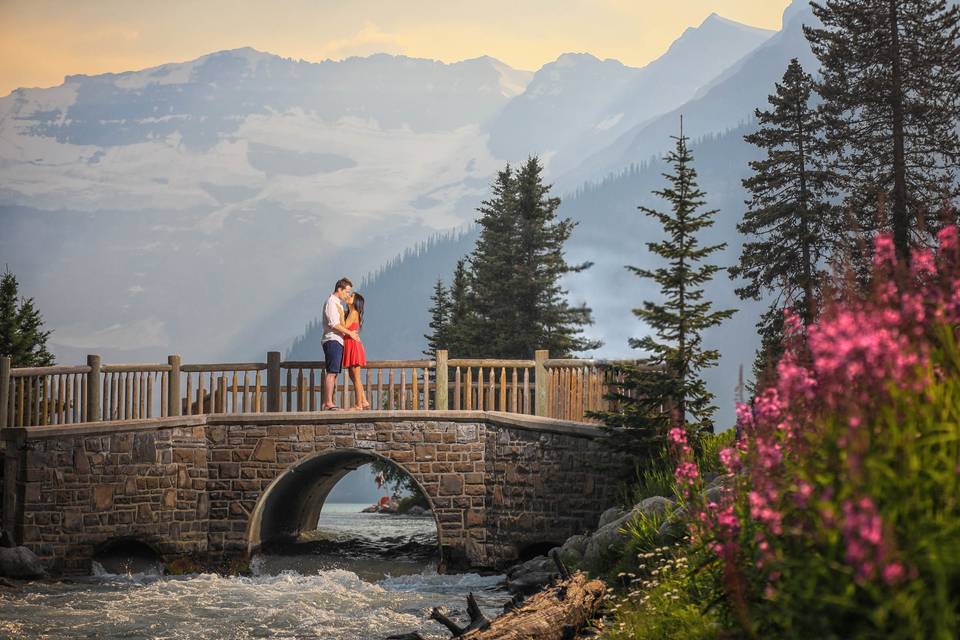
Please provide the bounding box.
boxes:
[208,421,485,563]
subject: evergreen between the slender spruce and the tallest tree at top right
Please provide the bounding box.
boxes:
[730,58,842,379]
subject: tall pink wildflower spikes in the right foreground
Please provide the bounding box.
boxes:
[684,226,960,590]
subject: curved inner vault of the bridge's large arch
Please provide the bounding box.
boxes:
[247,447,444,560]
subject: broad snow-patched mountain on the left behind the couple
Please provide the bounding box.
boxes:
[0,49,532,360]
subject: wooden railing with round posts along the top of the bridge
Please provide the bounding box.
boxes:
[0,351,644,428]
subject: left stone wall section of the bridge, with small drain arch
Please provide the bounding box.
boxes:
[20,427,209,573]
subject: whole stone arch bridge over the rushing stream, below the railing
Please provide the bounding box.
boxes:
[2,411,617,573]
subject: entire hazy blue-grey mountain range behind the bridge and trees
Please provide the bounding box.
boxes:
[0,0,815,430]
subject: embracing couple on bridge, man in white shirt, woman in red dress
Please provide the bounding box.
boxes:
[321,278,370,411]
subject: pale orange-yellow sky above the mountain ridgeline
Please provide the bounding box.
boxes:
[0,0,790,96]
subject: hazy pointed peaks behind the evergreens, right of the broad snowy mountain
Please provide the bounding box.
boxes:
[490,13,773,175]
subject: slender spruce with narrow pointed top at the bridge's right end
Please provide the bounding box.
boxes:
[596,124,735,456]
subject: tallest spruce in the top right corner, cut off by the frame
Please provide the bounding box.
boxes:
[804,0,960,260]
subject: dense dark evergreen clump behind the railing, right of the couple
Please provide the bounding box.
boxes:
[449,157,601,358]
